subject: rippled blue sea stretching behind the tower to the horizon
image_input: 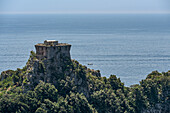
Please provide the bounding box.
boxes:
[0,14,170,86]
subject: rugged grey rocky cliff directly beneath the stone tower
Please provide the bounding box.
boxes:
[22,52,101,97]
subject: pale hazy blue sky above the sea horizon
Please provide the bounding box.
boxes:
[0,0,170,13]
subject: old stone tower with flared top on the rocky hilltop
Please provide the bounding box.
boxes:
[35,40,71,60]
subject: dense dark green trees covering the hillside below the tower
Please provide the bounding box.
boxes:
[0,51,170,113]
